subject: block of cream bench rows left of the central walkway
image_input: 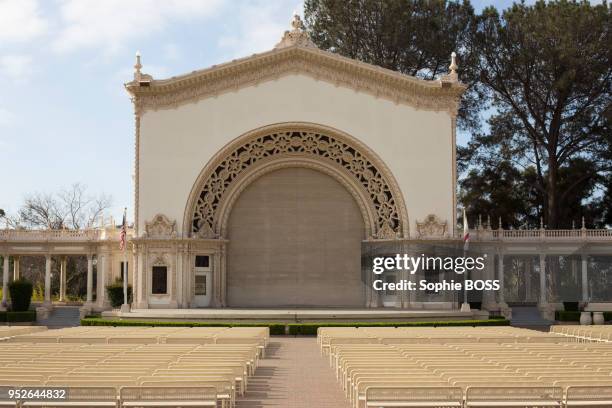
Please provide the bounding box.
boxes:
[0,328,268,407]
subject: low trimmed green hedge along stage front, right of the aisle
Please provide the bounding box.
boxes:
[287,319,510,336]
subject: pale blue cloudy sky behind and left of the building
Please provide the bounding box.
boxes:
[0,0,544,222]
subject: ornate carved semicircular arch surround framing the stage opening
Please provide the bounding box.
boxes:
[183,122,409,239]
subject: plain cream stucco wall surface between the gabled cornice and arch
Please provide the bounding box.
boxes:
[138,75,454,236]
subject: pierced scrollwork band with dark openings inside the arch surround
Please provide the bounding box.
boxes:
[191,131,402,239]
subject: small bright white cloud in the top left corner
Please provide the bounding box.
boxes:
[0,0,48,43]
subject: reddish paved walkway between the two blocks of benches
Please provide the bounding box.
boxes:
[236,337,349,408]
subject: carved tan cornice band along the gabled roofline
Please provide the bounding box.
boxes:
[125,47,465,115]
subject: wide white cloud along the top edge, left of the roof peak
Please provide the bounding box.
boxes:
[52,0,222,53]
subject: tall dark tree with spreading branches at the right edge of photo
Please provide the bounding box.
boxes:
[470,0,612,228]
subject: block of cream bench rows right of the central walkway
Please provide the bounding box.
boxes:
[318,328,612,407]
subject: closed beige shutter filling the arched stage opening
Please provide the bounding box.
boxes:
[227,168,365,307]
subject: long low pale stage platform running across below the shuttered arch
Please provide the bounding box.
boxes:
[102,308,489,323]
